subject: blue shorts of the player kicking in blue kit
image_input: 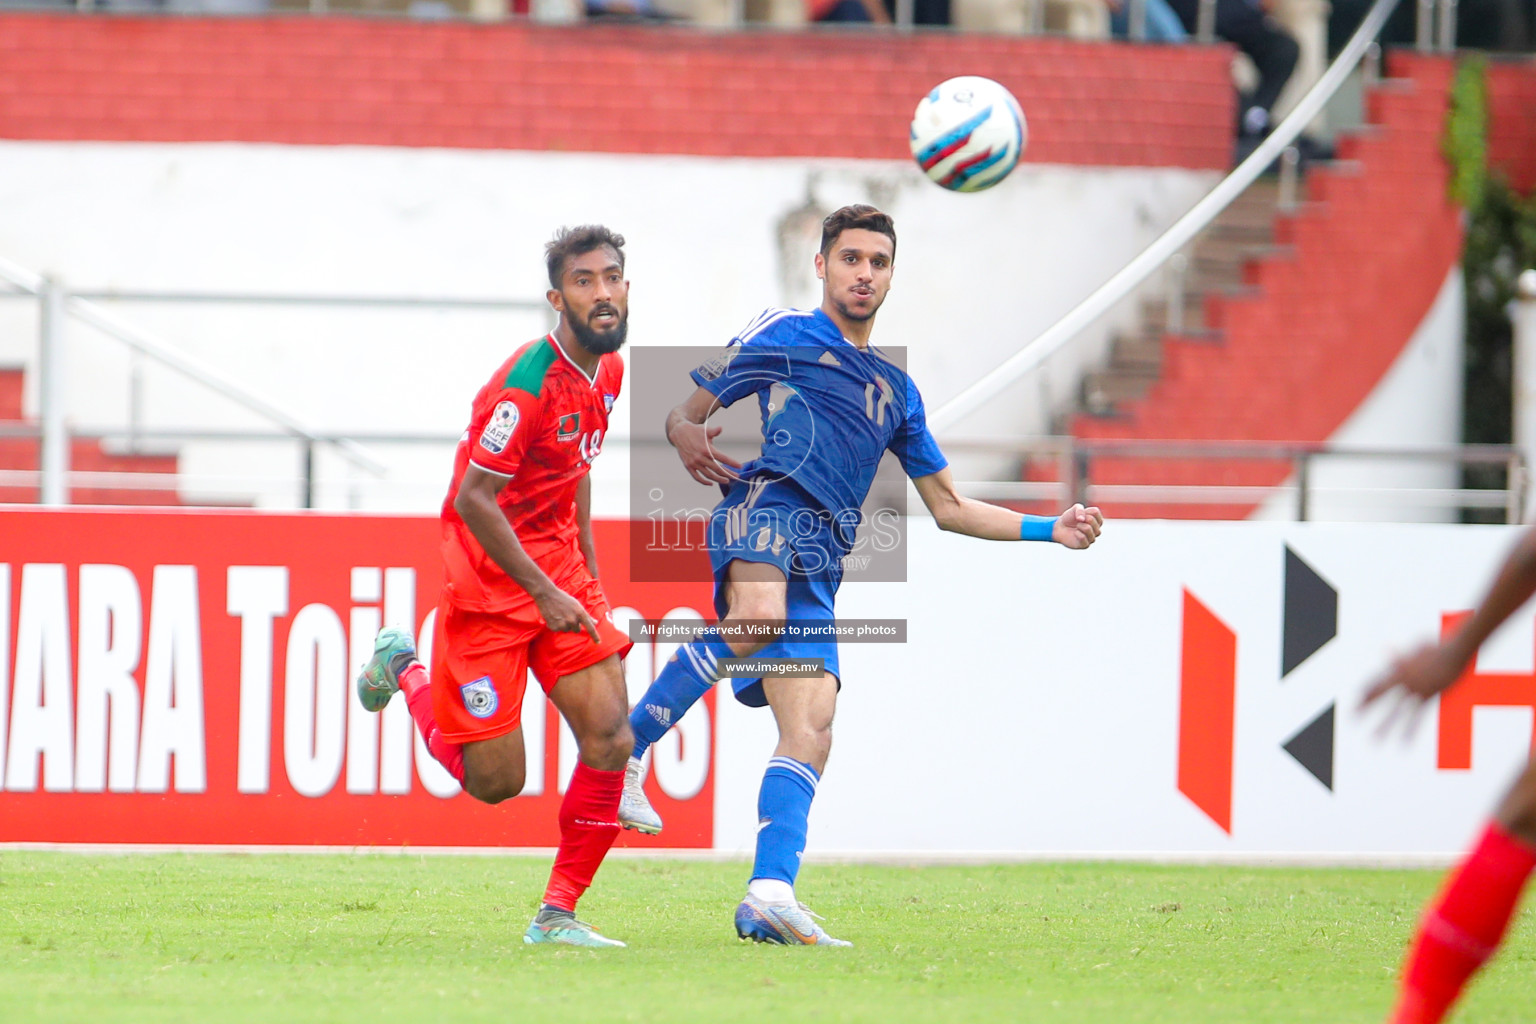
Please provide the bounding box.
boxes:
[710,477,857,708]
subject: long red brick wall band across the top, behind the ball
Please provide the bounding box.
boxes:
[0,14,1233,169]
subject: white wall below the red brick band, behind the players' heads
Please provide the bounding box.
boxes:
[0,141,1217,514]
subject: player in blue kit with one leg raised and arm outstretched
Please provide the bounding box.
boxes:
[619,206,1103,946]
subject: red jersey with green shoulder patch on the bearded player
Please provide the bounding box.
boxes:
[442,335,624,611]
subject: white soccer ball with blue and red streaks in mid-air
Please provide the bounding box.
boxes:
[912,75,1028,192]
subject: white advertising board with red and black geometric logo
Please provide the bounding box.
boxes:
[716,520,1536,860]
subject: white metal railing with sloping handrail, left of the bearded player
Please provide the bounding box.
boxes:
[0,259,550,508]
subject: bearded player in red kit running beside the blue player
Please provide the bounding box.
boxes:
[358,226,634,946]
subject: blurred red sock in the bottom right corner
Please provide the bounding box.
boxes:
[1390,821,1536,1024]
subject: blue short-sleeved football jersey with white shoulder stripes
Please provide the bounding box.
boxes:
[691,309,948,516]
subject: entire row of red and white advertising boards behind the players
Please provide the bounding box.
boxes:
[0,508,1536,861]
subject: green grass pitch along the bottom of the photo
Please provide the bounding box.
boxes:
[0,852,1536,1024]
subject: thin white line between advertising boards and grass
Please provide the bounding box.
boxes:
[0,843,1461,869]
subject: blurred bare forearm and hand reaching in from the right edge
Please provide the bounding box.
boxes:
[1361,530,1536,729]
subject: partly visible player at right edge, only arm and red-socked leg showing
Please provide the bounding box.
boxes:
[1364,530,1536,1024]
